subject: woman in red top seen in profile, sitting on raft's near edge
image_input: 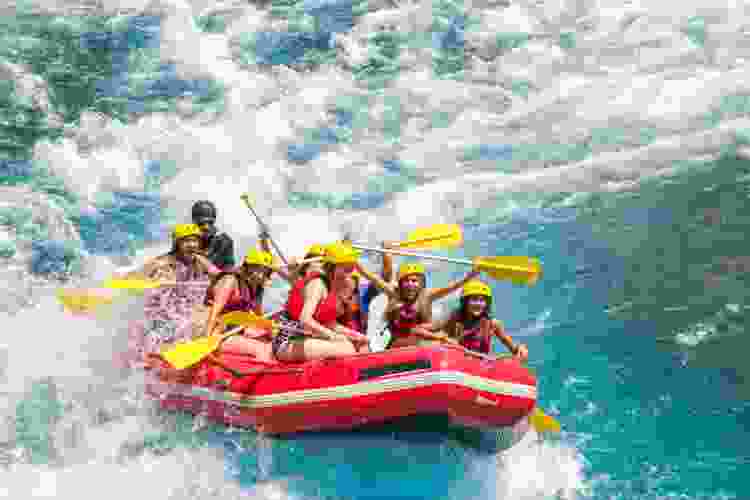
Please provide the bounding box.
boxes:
[272,243,368,362]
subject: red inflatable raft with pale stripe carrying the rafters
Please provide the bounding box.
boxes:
[148,345,537,441]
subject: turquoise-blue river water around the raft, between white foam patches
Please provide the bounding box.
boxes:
[0,2,750,500]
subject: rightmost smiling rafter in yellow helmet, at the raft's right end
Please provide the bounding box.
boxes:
[430,280,529,361]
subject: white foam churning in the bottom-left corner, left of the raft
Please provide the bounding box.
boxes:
[0,290,296,500]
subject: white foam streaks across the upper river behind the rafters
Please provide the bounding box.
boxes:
[17,0,748,227]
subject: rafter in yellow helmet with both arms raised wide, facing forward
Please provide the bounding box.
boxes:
[358,255,480,348]
